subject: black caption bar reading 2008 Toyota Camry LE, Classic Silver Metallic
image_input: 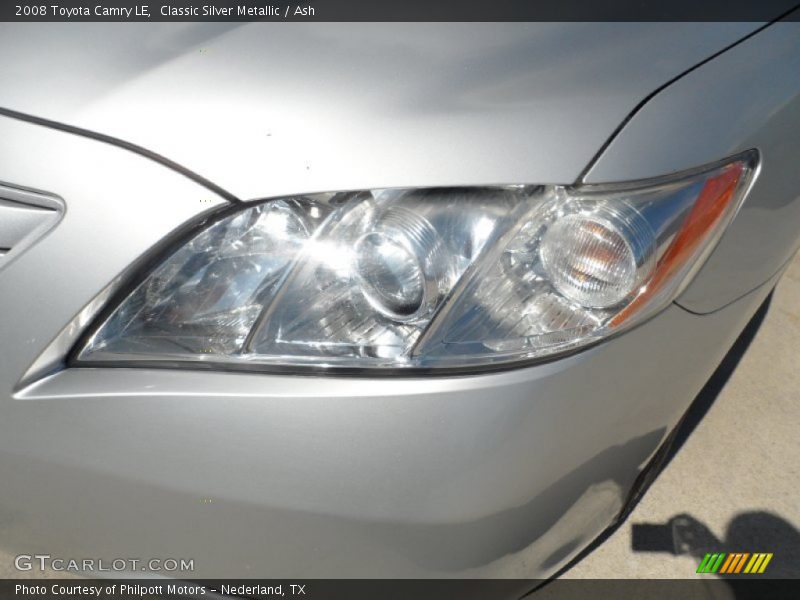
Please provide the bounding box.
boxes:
[0,0,800,22]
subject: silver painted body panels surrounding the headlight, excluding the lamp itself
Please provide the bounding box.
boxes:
[0,22,800,578]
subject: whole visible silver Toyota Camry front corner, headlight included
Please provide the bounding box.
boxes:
[0,21,800,577]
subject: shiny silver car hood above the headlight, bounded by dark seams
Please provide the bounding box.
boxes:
[0,23,761,199]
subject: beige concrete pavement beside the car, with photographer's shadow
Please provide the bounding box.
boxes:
[563,255,800,579]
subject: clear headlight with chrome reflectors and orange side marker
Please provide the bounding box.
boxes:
[77,151,757,369]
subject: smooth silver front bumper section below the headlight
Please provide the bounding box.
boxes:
[0,274,771,578]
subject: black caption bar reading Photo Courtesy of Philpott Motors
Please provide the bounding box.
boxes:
[0,576,800,600]
